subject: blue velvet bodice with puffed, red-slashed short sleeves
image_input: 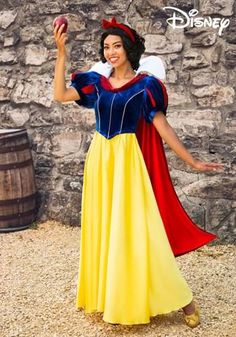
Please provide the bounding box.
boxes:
[71,71,168,138]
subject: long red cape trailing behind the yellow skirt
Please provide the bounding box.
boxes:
[136,118,217,256]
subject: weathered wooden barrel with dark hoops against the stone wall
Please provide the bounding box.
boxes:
[0,129,36,232]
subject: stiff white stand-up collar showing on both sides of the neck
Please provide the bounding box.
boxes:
[89,56,166,80]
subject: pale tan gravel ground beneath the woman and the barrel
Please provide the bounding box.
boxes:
[0,221,236,337]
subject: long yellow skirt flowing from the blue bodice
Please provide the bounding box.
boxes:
[76,131,193,324]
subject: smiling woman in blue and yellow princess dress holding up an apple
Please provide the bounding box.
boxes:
[54,18,222,328]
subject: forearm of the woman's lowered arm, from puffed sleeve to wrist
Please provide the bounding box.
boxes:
[153,113,195,167]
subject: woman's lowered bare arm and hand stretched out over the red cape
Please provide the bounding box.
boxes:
[153,111,224,171]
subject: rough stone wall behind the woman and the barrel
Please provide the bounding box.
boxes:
[0,0,236,242]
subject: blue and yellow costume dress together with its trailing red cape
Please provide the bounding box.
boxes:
[71,57,218,324]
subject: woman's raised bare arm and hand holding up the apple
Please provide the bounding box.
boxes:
[54,25,80,102]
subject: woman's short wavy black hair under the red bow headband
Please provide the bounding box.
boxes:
[99,25,145,70]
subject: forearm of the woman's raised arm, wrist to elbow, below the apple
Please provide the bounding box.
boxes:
[54,52,66,101]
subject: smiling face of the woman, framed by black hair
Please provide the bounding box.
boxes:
[103,35,129,67]
